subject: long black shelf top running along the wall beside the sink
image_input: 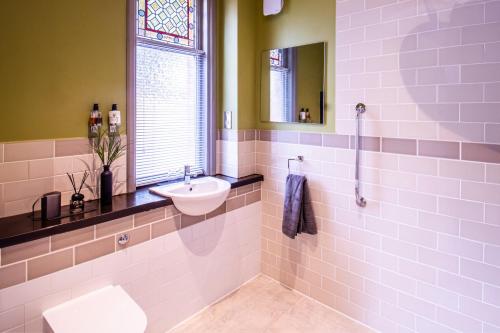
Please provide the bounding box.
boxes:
[0,174,264,248]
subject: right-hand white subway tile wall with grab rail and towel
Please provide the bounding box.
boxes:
[256,0,500,333]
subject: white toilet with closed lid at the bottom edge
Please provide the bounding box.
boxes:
[43,286,147,333]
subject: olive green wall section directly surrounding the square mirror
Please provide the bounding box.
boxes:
[254,0,335,132]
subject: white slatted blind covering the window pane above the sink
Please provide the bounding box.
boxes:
[136,44,207,186]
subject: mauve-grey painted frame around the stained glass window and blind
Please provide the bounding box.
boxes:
[126,0,217,192]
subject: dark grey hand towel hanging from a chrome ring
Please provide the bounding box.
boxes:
[282,175,318,239]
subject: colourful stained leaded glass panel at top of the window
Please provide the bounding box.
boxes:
[137,0,196,47]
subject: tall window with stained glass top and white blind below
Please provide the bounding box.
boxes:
[129,0,213,186]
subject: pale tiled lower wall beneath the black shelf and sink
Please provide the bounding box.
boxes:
[0,202,261,333]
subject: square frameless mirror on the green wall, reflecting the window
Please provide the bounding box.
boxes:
[260,42,326,124]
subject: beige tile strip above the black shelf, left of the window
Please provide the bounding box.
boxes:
[0,139,127,217]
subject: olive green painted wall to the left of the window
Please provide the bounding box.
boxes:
[0,0,126,141]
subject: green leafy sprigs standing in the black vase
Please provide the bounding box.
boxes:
[90,129,127,166]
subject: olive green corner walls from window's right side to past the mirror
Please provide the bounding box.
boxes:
[217,0,335,132]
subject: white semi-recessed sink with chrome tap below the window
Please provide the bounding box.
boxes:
[149,177,231,216]
